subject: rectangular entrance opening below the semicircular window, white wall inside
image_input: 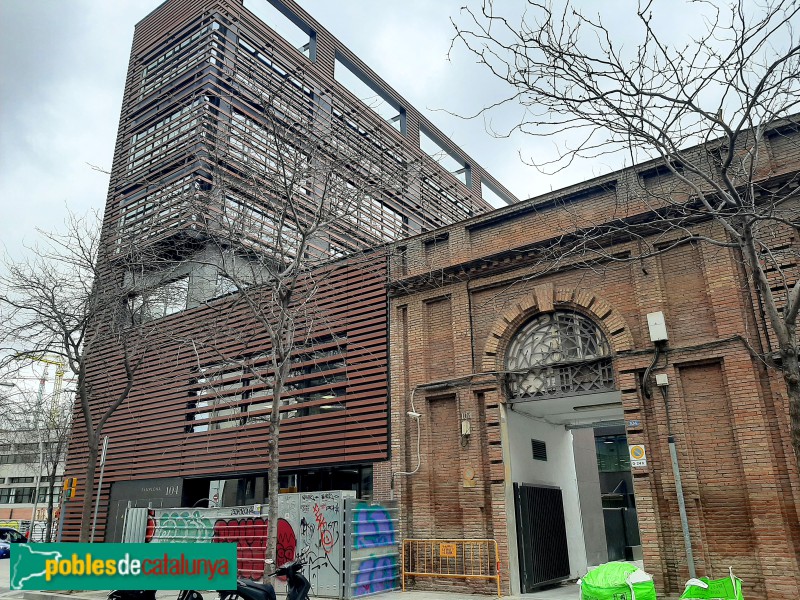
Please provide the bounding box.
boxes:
[507,391,641,593]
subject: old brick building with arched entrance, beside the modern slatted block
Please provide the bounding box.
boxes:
[389,120,800,600]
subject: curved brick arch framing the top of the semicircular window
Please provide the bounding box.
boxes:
[482,284,633,371]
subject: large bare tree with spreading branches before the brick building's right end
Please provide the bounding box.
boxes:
[454,0,800,465]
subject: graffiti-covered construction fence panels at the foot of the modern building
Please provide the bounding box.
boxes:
[123,491,400,598]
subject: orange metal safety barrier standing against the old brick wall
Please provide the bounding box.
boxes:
[401,539,501,597]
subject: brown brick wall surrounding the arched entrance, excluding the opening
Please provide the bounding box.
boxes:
[390,139,800,600]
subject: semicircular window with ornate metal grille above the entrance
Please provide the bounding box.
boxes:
[506,312,614,399]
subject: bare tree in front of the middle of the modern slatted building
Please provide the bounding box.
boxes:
[184,74,414,578]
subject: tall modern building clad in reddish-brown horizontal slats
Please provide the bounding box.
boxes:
[65,0,516,541]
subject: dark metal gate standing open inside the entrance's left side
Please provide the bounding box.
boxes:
[514,483,570,594]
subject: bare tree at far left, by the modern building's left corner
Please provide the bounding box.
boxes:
[0,213,183,542]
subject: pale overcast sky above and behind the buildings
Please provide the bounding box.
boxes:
[0,0,752,254]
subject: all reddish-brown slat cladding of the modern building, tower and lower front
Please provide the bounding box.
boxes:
[65,0,516,539]
